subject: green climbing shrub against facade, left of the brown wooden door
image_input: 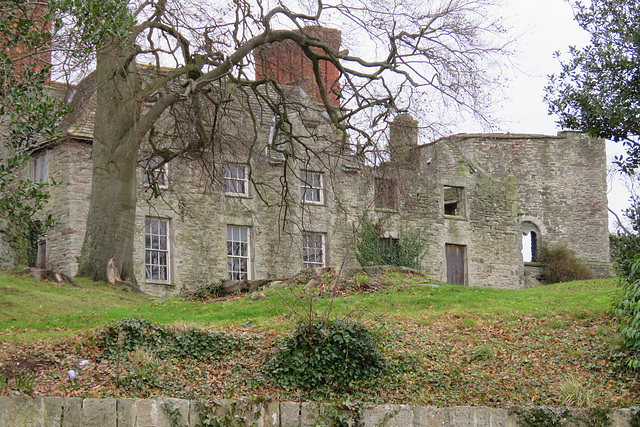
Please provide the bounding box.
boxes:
[355,216,426,270]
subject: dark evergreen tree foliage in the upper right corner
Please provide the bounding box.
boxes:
[546,0,640,173]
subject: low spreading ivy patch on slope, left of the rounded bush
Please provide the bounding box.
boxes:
[98,318,239,360]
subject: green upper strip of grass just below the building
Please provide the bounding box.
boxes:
[0,274,620,339]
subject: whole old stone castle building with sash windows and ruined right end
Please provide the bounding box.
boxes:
[0,26,609,295]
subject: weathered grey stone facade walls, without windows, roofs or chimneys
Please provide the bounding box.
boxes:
[18,108,609,295]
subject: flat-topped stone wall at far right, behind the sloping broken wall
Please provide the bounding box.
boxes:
[440,132,609,274]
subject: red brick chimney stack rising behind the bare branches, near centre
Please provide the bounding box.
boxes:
[255,26,342,107]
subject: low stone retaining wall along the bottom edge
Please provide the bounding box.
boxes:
[0,396,638,427]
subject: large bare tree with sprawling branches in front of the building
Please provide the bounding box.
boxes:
[41,0,504,280]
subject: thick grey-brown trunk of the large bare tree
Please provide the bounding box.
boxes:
[78,43,141,283]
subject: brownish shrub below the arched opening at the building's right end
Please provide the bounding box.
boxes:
[538,246,593,284]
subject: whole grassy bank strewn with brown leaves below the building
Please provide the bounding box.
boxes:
[0,274,640,407]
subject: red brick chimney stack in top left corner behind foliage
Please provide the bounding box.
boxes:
[0,1,51,76]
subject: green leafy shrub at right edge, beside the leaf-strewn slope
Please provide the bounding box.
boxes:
[614,260,640,370]
